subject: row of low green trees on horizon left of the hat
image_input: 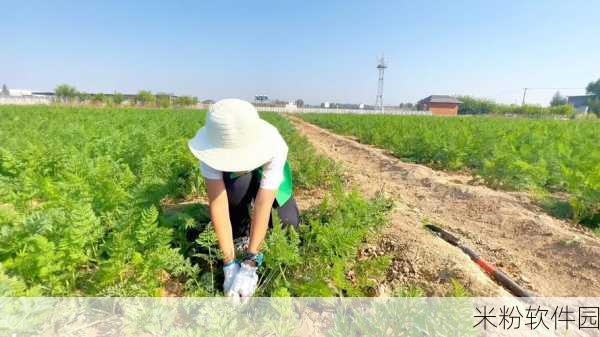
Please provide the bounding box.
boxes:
[54,84,198,108]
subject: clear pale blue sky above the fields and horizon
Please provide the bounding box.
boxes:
[0,0,600,104]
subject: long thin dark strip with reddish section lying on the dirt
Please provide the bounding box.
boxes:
[425,224,536,297]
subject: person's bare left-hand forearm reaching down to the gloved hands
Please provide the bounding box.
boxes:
[204,179,235,263]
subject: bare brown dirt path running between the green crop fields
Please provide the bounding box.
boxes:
[290,117,600,296]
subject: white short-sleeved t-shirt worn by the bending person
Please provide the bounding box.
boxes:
[200,133,288,190]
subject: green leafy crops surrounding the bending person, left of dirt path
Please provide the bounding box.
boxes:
[0,106,391,296]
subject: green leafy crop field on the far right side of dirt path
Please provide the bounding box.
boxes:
[301,114,600,230]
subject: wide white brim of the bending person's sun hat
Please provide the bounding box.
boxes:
[188,119,280,172]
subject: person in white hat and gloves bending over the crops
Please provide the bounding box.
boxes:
[188,99,300,297]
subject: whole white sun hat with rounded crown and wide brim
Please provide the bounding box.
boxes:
[188,98,281,172]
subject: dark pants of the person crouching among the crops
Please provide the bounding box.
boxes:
[223,169,300,239]
